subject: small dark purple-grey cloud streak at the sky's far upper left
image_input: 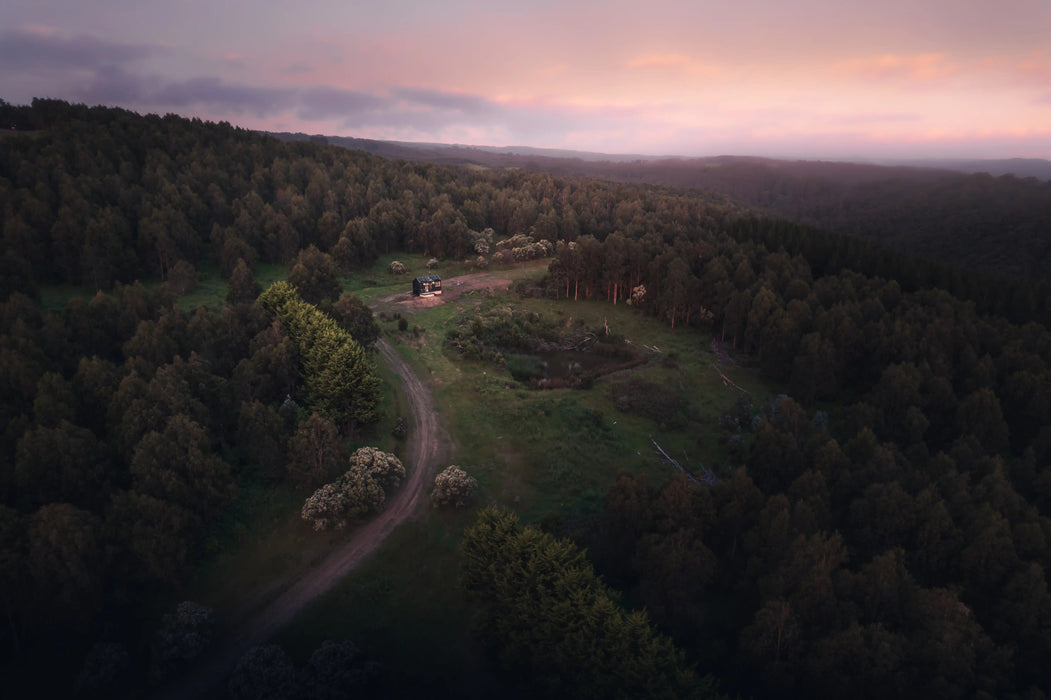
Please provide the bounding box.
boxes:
[0,30,157,70]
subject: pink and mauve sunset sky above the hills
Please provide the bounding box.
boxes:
[0,0,1051,160]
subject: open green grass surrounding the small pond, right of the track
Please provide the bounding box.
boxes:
[386,283,764,519]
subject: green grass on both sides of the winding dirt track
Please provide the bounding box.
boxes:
[184,255,768,697]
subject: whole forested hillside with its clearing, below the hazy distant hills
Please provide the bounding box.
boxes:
[0,100,1051,698]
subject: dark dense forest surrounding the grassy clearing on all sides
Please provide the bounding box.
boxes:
[0,100,1051,698]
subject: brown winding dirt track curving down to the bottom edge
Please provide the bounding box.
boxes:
[160,339,448,698]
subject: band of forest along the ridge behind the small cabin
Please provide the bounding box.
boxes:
[0,100,1051,324]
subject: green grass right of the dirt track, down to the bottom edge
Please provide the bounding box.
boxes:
[269,260,764,697]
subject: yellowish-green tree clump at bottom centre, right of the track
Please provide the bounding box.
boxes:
[462,509,719,698]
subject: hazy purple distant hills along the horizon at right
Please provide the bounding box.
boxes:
[274,133,1051,281]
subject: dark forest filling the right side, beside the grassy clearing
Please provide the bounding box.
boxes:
[529,204,1051,697]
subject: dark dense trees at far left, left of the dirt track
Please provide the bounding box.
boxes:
[0,273,301,697]
